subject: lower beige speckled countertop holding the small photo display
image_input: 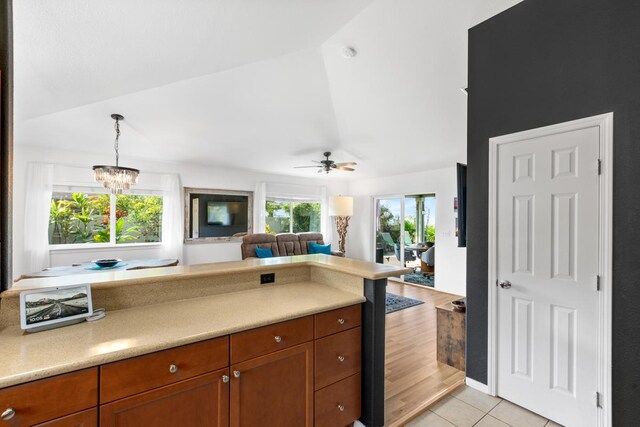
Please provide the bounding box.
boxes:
[0,282,364,388]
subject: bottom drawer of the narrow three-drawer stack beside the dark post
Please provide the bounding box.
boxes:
[314,373,362,427]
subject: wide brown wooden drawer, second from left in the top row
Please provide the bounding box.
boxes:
[100,337,229,403]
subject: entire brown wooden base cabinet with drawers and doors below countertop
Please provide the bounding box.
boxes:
[0,305,362,427]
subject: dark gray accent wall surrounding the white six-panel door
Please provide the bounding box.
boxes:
[467,0,640,426]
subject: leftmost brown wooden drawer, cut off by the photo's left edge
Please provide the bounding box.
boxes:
[0,368,98,426]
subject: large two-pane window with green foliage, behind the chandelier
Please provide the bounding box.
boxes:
[49,191,162,245]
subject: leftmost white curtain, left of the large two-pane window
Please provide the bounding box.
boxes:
[24,163,53,273]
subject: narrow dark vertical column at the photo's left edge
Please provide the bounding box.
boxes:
[0,0,13,290]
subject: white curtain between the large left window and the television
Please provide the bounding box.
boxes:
[161,174,184,264]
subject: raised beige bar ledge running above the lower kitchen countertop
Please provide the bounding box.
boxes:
[11,254,412,296]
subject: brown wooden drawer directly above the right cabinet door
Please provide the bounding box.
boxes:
[231,316,313,363]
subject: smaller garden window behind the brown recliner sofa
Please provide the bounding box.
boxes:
[265,200,321,234]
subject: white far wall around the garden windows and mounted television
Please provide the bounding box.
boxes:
[13,144,347,277]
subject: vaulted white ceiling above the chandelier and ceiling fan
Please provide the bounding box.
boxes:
[14,0,519,178]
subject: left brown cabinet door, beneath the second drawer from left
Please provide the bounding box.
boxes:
[100,369,229,427]
